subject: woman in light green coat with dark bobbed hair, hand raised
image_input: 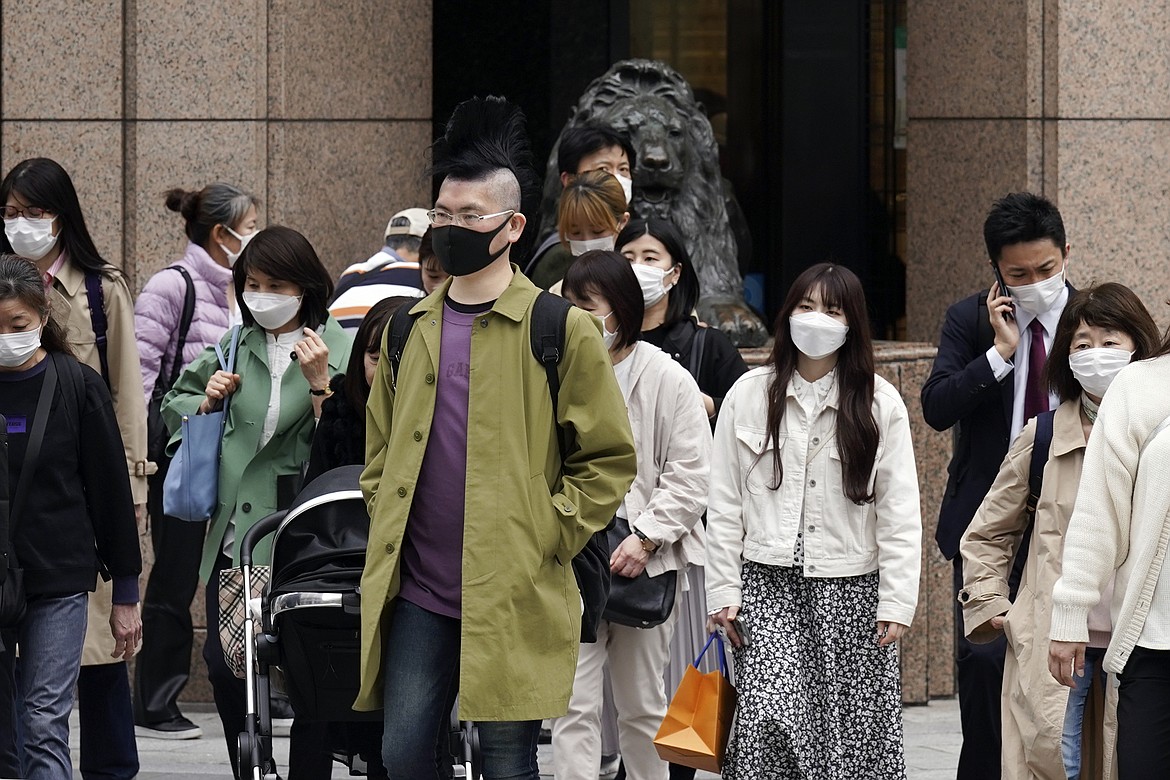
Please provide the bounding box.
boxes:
[163,227,350,776]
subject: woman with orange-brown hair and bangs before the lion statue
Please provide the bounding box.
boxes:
[532,171,629,295]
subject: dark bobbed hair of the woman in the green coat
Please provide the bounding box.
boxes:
[232,225,333,329]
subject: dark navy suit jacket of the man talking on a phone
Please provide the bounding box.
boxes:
[922,285,1076,560]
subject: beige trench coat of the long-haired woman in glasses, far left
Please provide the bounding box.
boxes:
[49,261,153,667]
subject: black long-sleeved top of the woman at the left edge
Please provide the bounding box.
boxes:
[0,356,142,602]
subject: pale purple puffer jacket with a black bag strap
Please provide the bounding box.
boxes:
[135,243,232,405]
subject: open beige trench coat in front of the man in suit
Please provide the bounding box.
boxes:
[958,398,1117,780]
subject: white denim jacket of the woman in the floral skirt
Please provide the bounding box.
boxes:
[707,366,922,626]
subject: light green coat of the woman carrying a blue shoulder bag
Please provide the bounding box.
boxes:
[163,317,351,582]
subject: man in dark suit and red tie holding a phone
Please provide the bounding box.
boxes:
[922,193,1072,780]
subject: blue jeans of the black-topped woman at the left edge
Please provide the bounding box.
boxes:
[0,593,89,780]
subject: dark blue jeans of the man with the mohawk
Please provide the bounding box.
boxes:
[381,599,541,780]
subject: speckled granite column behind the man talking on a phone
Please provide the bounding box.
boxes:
[907,0,1170,696]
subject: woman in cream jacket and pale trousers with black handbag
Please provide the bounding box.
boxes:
[552,250,711,780]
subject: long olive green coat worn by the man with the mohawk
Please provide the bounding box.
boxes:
[355,265,636,720]
